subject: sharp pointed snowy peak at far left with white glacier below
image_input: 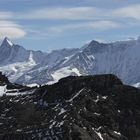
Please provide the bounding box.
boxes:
[0,38,47,83]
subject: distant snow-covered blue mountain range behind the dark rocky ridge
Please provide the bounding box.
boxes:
[0,37,140,85]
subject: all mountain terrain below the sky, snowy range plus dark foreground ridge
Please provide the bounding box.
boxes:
[0,38,140,140]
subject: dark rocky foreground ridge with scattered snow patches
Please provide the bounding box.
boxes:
[0,73,140,140]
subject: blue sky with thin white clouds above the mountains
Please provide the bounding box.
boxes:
[0,0,140,51]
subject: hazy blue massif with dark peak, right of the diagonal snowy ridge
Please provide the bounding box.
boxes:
[55,38,140,85]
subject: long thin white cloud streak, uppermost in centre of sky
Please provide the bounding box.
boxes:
[19,7,100,20]
